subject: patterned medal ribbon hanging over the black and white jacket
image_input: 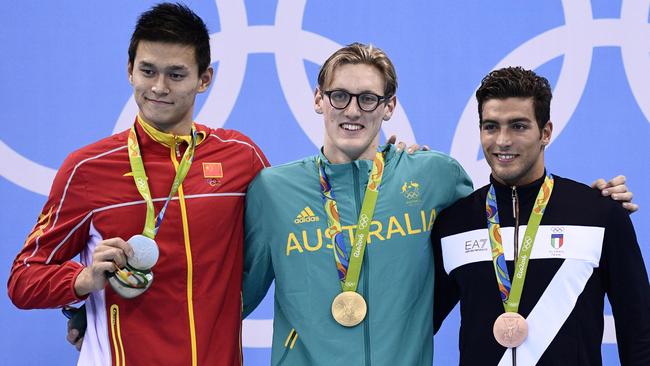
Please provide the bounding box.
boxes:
[485,172,553,313]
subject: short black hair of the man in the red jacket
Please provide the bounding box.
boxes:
[129,3,210,75]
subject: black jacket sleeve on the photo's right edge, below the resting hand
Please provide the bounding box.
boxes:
[603,203,650,365]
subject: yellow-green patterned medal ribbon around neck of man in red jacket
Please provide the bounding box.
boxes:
[128,121,197,239]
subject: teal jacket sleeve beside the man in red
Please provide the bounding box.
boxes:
[242,175,275,318]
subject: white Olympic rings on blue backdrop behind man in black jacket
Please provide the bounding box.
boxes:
[450,0,650,187]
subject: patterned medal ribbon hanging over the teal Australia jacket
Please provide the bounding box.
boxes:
[318,152,384,291]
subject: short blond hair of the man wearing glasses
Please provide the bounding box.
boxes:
[318,42,397,98]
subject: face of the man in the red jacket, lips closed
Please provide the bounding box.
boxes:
[128,41,213,135]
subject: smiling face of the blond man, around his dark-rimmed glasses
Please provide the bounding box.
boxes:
[314,64,396,164]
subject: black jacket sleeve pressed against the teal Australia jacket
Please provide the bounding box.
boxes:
[431,214,460,334]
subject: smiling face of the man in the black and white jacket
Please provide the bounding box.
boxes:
[481,98,553,186]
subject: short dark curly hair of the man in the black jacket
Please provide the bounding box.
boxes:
[476,66,553,130]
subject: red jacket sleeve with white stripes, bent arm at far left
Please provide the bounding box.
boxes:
[7,152,92,309]
